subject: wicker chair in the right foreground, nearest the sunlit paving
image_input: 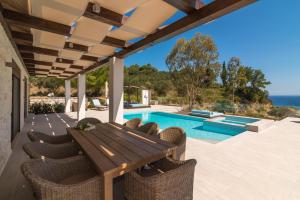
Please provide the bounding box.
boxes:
[124,158,196,200]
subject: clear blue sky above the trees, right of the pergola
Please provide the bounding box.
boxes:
[125,0,300,95]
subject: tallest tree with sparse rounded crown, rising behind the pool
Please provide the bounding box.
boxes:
[166,33,220,109]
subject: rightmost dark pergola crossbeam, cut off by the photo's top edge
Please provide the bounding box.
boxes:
[163,0,204,13]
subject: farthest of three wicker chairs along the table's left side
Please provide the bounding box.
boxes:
[27,131,72,144]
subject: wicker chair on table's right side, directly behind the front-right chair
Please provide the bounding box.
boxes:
[159,127,186,160]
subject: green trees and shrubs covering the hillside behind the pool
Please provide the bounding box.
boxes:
[31,33,297,119]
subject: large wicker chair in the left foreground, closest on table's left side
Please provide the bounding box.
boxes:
[21,156,103,200]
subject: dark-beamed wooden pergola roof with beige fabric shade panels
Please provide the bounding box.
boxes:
[0,0,255,79]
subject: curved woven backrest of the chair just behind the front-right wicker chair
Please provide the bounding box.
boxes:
[159,127,186,145]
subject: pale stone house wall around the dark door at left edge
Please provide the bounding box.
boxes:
[0,24,28,174]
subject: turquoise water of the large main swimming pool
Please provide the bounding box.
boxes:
[124,112,246,141]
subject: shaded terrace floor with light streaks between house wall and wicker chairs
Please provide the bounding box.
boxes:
[0,113,76,200]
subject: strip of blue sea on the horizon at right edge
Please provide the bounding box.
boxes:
[269,95,300,109]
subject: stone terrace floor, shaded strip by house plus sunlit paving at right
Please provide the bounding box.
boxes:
[0,111,300,200]
